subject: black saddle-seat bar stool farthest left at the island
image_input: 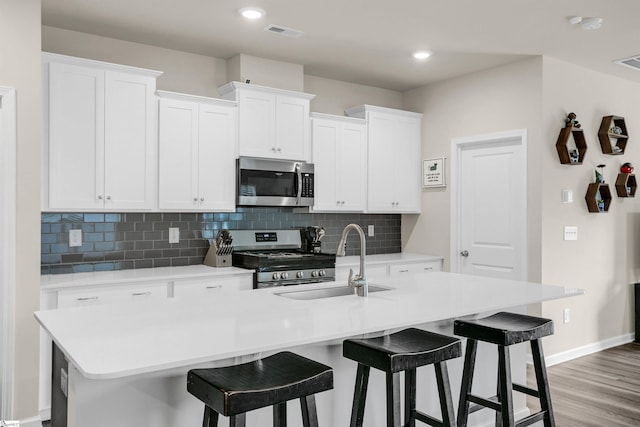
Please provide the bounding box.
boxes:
[187,351,333,427]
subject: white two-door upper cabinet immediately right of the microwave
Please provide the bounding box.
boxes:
[311,113,367,212]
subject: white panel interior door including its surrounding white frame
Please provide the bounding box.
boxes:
[451,131,527,280]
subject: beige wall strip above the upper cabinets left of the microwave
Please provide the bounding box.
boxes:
[42,26,227,98]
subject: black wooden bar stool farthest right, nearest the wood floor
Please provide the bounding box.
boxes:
[453,312,555,427]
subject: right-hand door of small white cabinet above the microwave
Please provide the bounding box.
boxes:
[276,95,309,161]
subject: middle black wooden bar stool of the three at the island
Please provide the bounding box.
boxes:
[342,328,462,427]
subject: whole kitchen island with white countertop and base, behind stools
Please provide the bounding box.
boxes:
[35,273,582,427]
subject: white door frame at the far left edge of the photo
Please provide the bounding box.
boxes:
[0,86,16,419]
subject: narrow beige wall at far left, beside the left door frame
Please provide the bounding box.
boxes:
[0,0,42,419]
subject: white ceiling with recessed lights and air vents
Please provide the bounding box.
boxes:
[42,0,640,91]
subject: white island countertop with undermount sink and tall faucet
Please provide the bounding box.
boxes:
[35,273,582,379]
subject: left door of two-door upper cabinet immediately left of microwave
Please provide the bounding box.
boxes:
[158,99,198,210]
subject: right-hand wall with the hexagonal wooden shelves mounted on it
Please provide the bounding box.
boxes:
[541,58,640,353]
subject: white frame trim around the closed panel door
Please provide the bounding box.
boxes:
[449,129,529,280]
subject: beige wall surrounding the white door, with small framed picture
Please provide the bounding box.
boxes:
[402,58,542,280]
